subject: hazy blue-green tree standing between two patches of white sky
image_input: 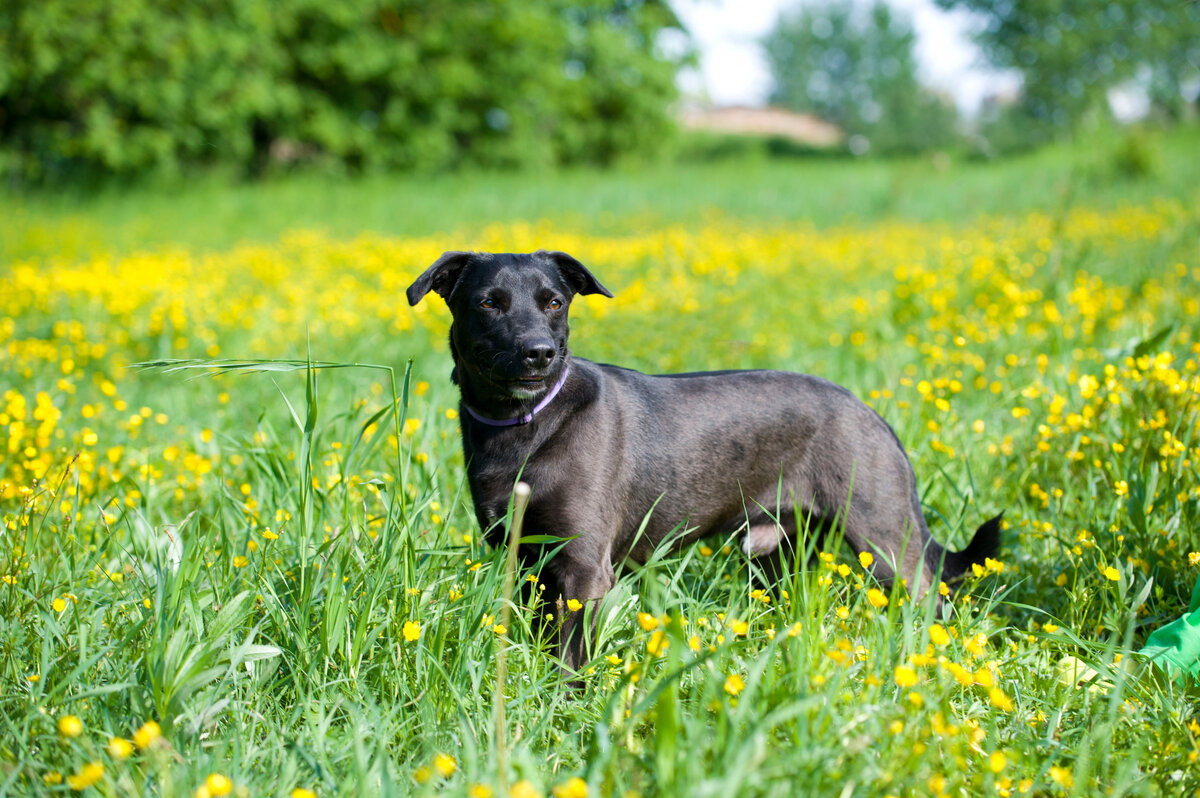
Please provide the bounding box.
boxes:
[764,1,958,152]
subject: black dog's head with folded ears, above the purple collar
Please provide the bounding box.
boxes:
[408,251,612,402]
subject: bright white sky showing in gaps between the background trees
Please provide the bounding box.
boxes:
[670,0,1018,114]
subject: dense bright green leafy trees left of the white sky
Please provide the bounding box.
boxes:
[0,0,679,179]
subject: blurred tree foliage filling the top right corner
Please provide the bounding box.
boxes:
[937,0,1200,130]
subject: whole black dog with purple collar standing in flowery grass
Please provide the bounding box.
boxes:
[408,252,1000,668]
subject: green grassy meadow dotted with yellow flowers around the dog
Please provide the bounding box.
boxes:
[0,131,1200,798]
